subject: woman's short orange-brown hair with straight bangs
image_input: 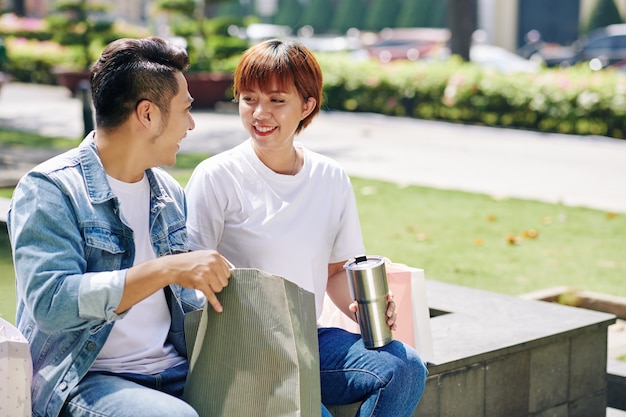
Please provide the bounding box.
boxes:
[233,39,322,133]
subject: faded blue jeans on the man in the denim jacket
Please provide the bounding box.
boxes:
[60,362,198,417]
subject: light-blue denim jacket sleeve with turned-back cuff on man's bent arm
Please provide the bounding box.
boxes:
[9,169,126,334]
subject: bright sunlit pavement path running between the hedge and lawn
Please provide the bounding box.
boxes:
[0,83,626,213]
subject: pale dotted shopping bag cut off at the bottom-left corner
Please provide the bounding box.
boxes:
[0,318,33,417]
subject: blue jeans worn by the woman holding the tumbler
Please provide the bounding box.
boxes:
[318,328,428,417]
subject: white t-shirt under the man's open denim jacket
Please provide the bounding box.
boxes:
[91,175,185,374]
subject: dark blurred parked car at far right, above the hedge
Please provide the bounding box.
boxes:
[531,24,626,69]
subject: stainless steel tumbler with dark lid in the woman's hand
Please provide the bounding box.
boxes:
[343,256,393,349]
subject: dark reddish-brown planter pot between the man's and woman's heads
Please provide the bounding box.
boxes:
[185,72,233,108]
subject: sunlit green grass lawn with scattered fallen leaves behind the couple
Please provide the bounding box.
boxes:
[0,128,626,322]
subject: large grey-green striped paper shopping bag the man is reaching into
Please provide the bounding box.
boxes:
[183,268,321,417]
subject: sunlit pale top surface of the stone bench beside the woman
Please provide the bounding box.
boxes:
[426,280,615,367]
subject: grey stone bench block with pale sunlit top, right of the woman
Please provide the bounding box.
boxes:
[330,280,615,417]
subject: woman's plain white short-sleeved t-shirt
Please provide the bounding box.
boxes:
[185,139,364,318]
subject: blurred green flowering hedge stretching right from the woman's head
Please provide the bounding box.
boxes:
[318,54,626,139]
